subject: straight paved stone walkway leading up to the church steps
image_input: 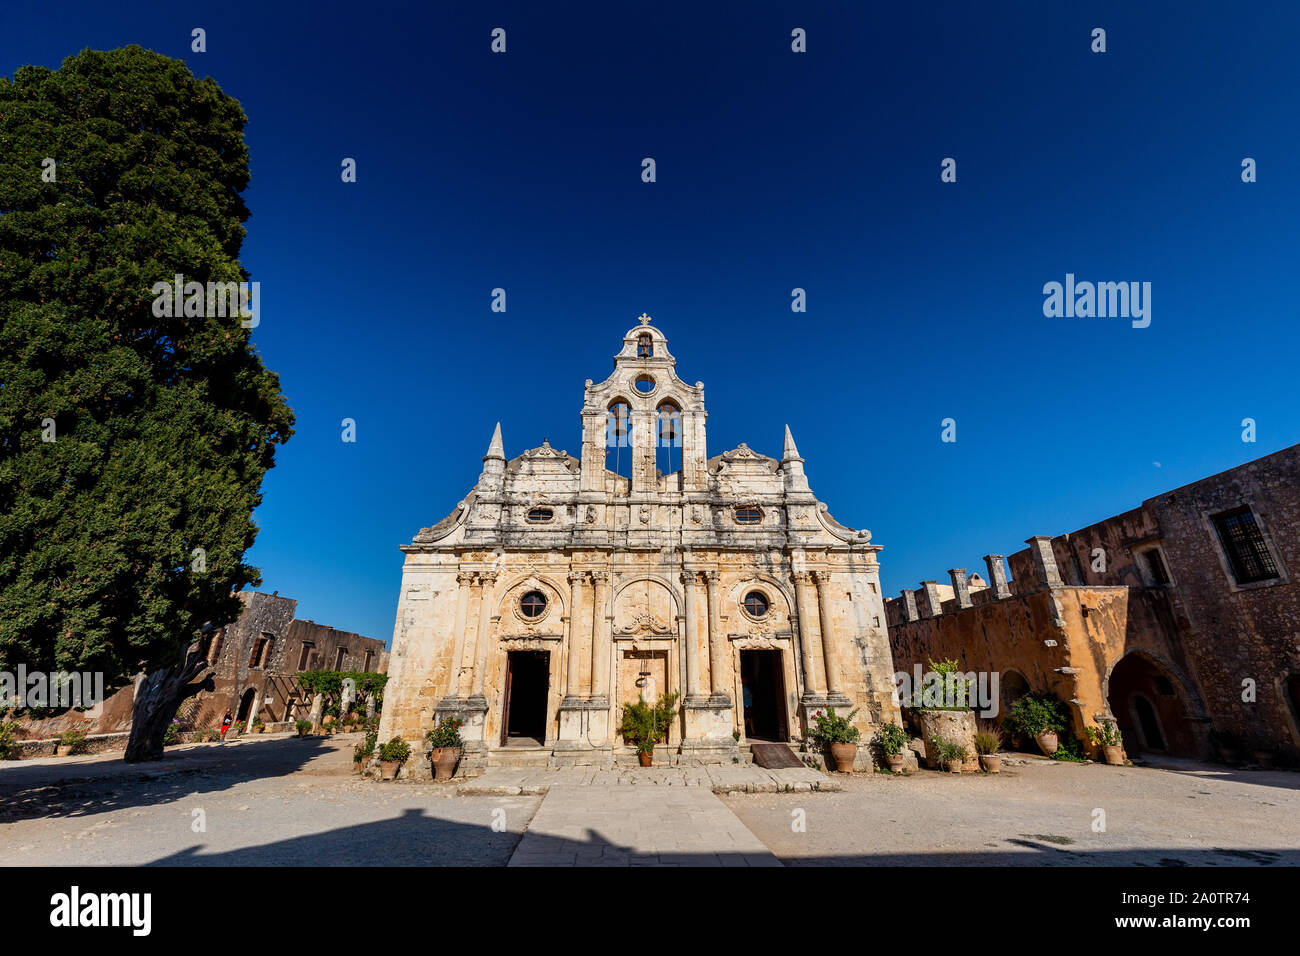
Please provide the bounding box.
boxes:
[510,783,781,866]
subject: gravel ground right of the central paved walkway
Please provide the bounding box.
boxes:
[722,758,1300,866]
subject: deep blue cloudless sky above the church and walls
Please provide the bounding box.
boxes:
[0,0,1300,640]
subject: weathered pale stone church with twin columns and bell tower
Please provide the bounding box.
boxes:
[380,315,898,771]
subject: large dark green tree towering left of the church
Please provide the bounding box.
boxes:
[0,47,293,761]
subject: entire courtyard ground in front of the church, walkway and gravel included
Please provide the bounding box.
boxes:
[0,737,1300,866]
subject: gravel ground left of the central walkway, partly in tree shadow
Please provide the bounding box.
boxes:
[0,737,541,866]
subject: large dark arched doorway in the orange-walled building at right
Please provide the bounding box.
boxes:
[1106,653,1200,757]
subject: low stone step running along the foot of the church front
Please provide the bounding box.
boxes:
[456,766,842,796]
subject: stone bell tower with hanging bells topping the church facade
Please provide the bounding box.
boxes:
[581,312,709,496]
